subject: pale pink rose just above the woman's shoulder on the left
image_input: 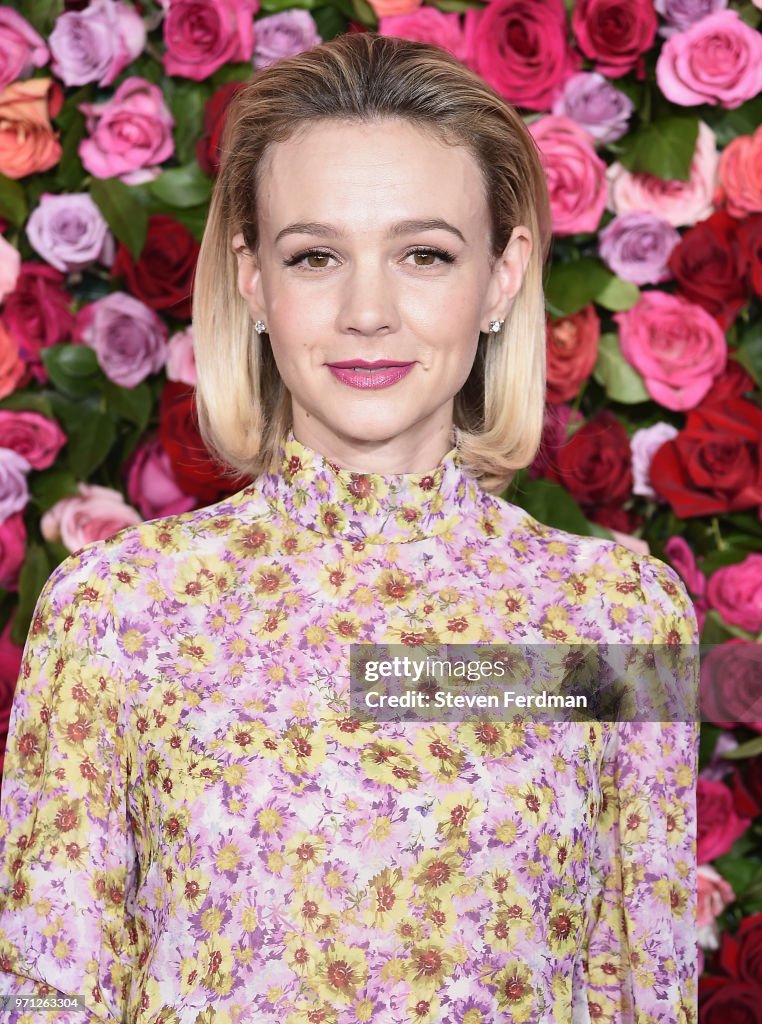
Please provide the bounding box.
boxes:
[40,483,142,552]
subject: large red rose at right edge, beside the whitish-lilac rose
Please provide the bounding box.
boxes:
[648,398,762,519]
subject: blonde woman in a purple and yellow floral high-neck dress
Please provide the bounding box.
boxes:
[0,34,696,1024]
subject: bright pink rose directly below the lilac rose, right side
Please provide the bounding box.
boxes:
[613,291,727,412]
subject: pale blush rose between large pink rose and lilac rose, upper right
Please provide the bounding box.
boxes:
[606,121,720,227]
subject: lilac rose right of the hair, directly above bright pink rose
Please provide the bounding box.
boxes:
[598,210,680,285]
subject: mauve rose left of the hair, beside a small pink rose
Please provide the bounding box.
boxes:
[76,292,168,387]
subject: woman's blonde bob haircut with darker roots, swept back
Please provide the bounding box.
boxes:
[193,33,551,494]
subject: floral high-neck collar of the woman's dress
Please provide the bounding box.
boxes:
[259,428,483,544]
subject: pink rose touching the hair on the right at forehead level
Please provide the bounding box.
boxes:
[530,114,606,234]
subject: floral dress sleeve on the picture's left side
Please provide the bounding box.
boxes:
[0,545,137,1024]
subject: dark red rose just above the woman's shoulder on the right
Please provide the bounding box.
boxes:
[551,410,632,512]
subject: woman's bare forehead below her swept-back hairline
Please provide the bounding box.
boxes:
[257,119,488,239]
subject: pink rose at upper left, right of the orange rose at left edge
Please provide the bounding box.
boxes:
[79,75,174,184]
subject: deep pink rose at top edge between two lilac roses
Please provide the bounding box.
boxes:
[164,0,259,82]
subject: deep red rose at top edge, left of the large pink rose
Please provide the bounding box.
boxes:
[572,0,658,78]
